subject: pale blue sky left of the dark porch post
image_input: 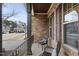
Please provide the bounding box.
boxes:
[2,3,27,23]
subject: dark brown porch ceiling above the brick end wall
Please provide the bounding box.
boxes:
[33,3,51,13]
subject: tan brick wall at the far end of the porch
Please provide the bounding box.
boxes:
[32,15,48,42]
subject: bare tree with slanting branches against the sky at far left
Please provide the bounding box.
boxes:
[2,4,18,33]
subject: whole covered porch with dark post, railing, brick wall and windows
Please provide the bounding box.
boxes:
[1,3,79,56]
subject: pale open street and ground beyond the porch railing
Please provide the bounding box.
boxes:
[2,33,25,51]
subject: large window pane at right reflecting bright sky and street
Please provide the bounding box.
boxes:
[64,11,78,48]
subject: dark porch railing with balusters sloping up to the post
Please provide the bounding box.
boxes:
[0,35,33,56]
